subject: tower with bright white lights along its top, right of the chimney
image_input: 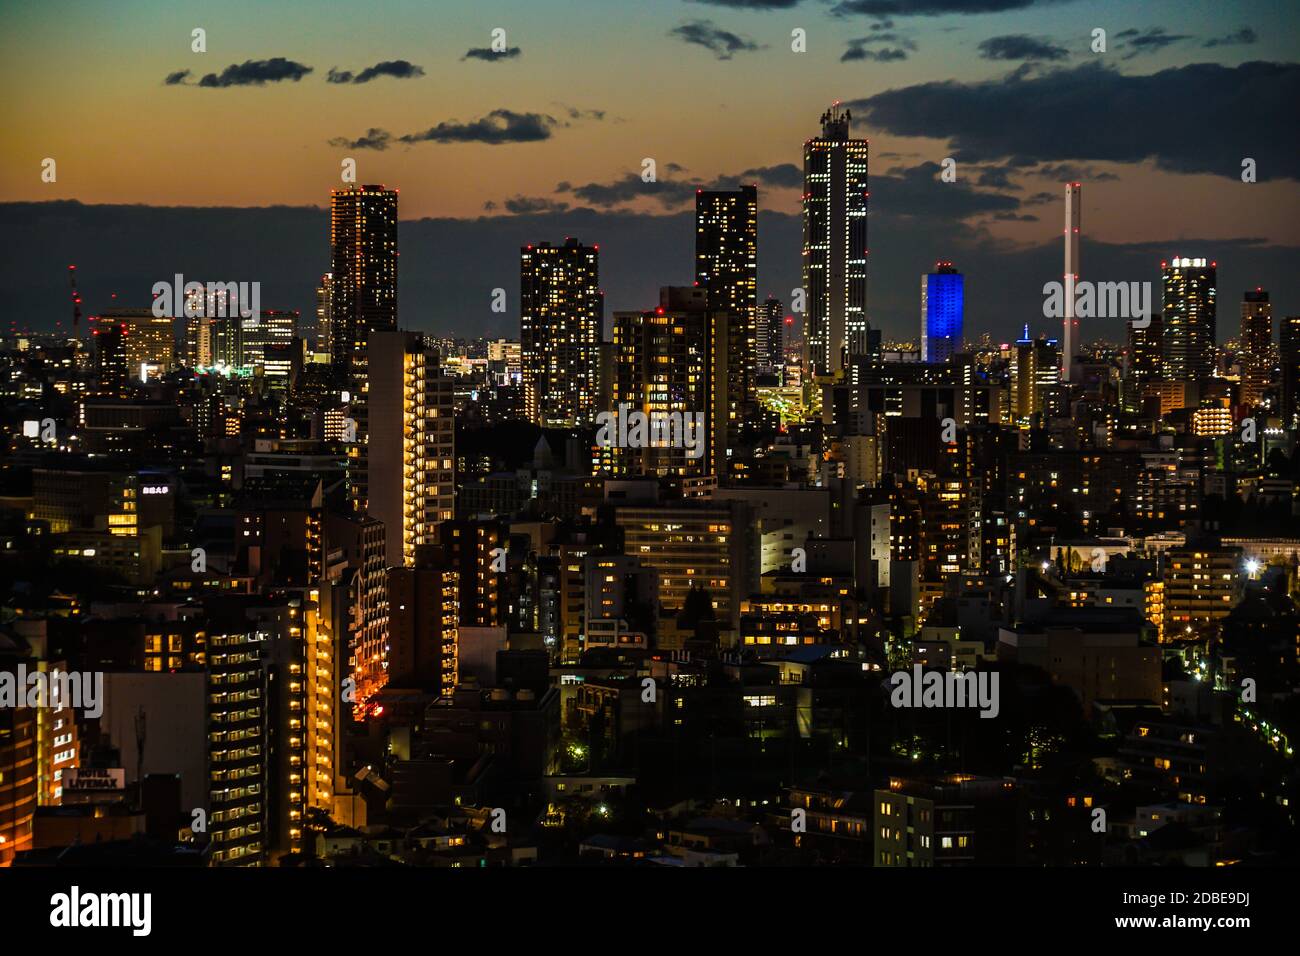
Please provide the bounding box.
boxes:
[1160,256,1218,381]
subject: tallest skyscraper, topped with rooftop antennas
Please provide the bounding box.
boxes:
[803,105,870,375]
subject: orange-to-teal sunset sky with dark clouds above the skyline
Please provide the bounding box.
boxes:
[0,0,1300,337]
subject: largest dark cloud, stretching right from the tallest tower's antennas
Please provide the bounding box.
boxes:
[846,61,1300,179]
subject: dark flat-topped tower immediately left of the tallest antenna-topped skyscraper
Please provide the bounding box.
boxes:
[696,186,758,403]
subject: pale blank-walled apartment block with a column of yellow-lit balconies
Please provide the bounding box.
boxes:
[367,332,455,567]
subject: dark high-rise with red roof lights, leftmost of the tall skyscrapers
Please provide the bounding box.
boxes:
[330,186,398,377]
